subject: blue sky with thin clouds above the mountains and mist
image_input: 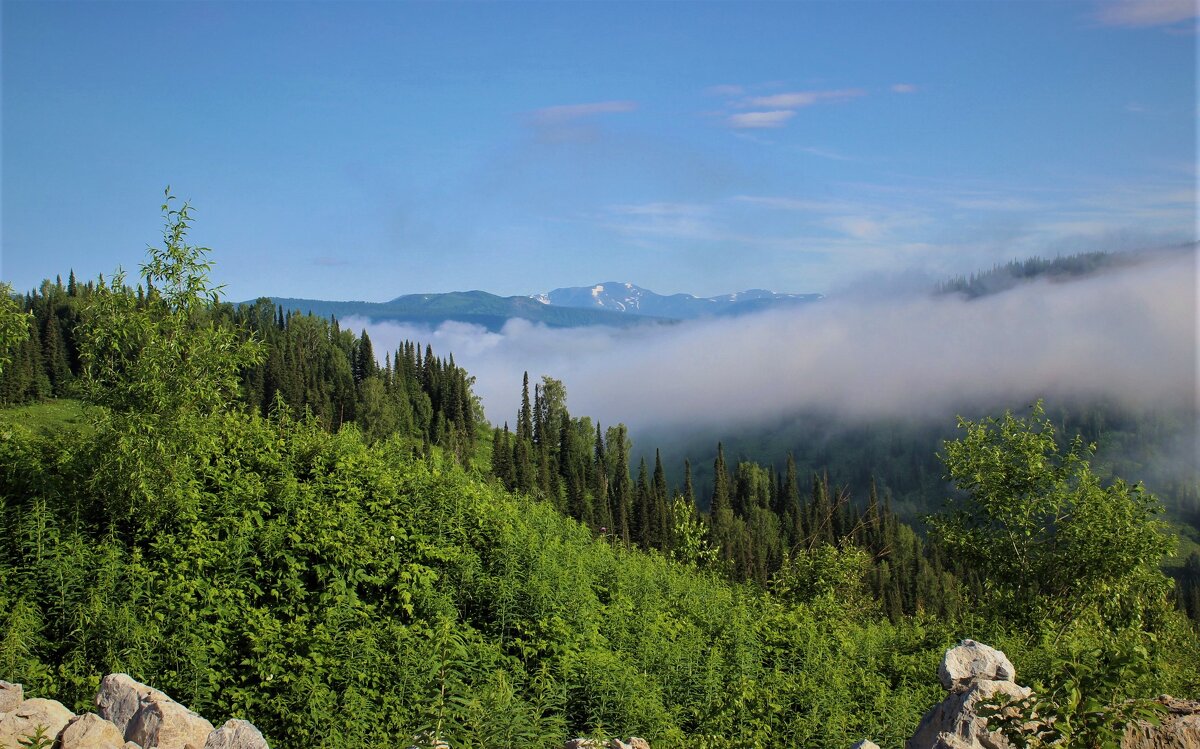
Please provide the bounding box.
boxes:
[0,0,1196,300]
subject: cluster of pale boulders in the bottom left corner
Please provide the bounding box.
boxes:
[0,673,269,749]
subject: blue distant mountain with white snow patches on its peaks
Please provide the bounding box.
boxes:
[532,281,822,319]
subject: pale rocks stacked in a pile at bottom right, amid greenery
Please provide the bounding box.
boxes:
[905,640,1030,749]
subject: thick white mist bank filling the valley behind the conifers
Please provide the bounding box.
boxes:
[343,250,1198,432]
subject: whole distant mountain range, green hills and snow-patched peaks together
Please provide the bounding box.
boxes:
[256,281,822,330]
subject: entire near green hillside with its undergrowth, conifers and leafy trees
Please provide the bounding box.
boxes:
[0,200,1200,749]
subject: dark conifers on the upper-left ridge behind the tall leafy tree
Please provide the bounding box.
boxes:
[0,272,482,460]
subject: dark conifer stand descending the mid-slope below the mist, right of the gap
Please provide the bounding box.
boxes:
[491,375,974,621]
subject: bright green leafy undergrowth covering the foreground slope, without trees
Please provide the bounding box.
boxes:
[0,403,958,747]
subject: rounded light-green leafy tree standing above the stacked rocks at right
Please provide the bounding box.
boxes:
[932,403,1171,628]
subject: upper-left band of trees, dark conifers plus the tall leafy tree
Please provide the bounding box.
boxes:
[0,225,482,461]
